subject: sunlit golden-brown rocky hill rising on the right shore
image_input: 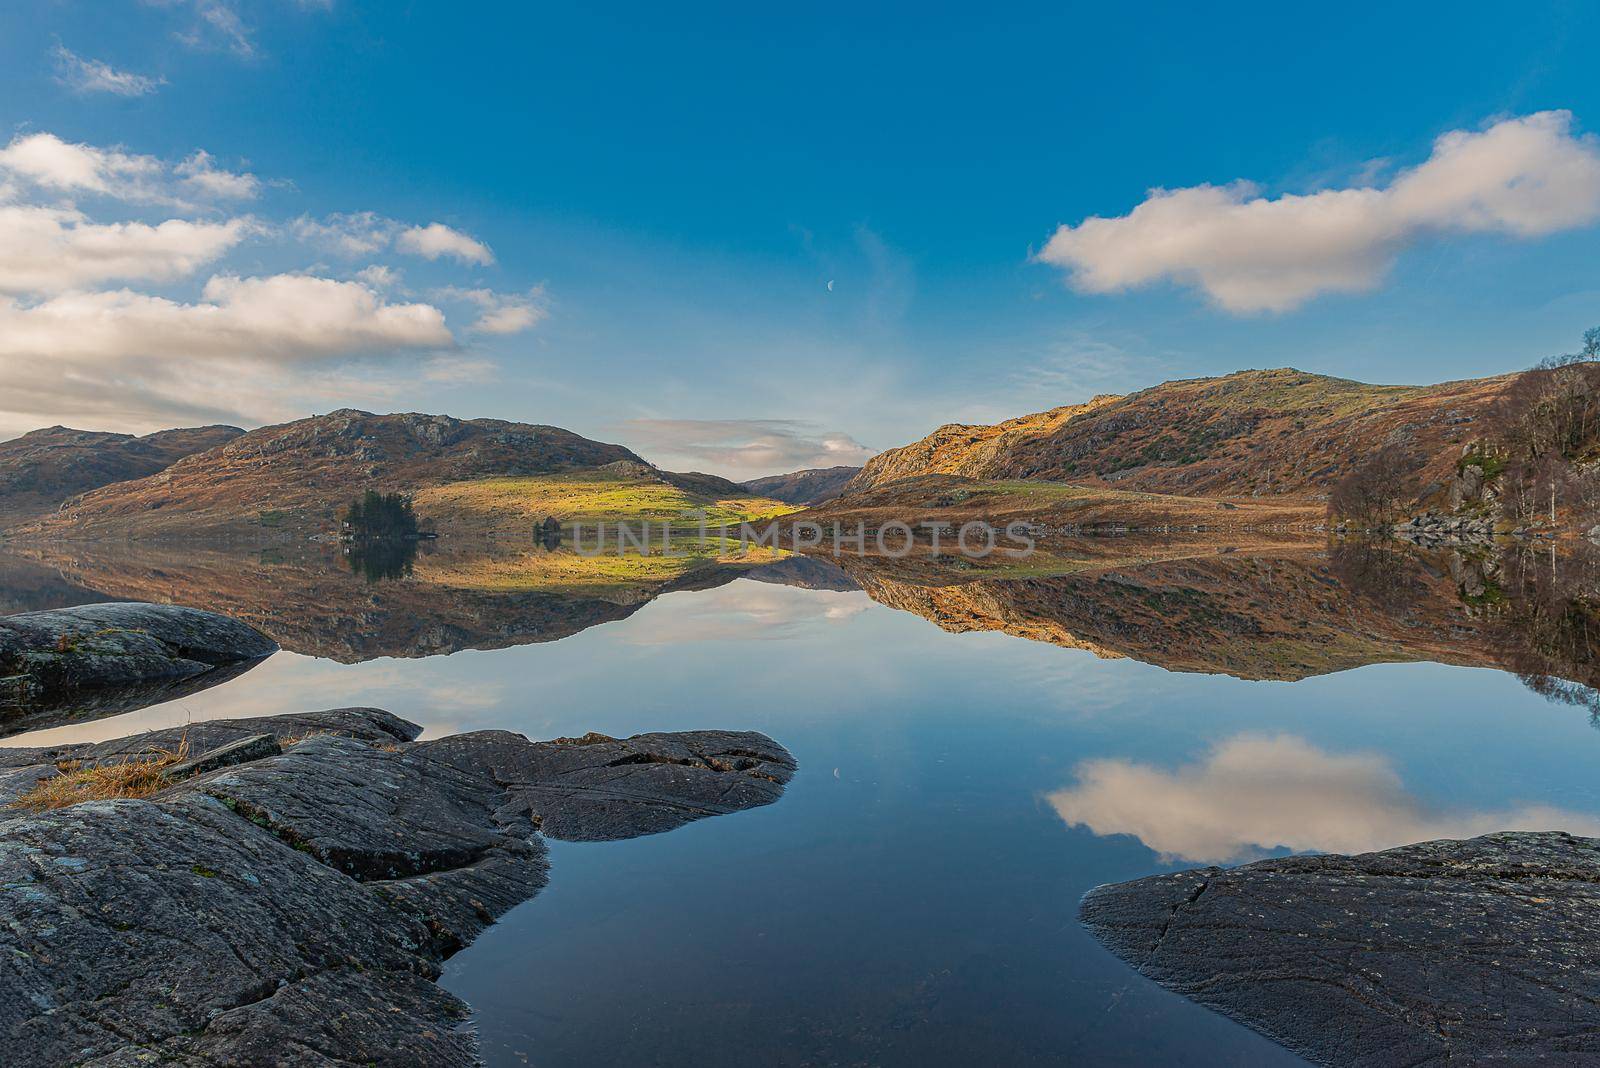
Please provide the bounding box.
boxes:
[846,368,1512,500]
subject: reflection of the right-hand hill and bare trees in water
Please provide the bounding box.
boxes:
[842,542,1600,710]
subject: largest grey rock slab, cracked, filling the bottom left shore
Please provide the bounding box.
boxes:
[0,708,794,1068]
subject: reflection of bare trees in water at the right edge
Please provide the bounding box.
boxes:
[1490,542,1600,719]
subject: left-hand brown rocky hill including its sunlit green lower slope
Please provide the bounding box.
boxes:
[14,409,773,542]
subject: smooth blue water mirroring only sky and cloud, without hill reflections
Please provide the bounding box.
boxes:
[6,549,1600,1066]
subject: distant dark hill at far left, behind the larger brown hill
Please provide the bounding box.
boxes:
[0,427,245,529]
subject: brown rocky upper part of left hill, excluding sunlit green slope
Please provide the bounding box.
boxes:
[18,409,653,540]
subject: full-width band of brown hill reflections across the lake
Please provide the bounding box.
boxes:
[0,537,1600,697]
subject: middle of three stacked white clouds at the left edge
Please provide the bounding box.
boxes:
[0,205,253,294]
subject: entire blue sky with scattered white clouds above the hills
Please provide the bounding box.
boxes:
[0,0,1600,478]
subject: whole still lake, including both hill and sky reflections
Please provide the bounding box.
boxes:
[0,542,1600,1066]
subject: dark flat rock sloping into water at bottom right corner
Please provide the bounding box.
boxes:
[1082,831,1600,1066]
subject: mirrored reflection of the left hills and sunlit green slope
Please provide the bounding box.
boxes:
[0,542,812,664]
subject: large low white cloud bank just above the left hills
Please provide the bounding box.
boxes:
[0,275,457,432]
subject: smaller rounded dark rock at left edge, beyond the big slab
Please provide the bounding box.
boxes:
[0,603,278,735]
